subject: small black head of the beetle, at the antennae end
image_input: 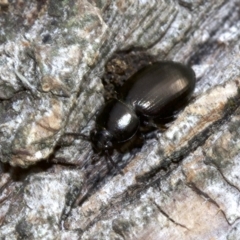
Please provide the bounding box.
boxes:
[90,129,113,152]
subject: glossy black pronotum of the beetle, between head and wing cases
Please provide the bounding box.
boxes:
[96,99,139,142]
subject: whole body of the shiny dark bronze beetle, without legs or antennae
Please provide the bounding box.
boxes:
[90,61,196,152]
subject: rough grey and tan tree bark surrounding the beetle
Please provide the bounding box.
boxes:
[0,0,240,240]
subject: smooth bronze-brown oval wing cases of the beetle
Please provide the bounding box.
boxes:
[119,62,196,118]
